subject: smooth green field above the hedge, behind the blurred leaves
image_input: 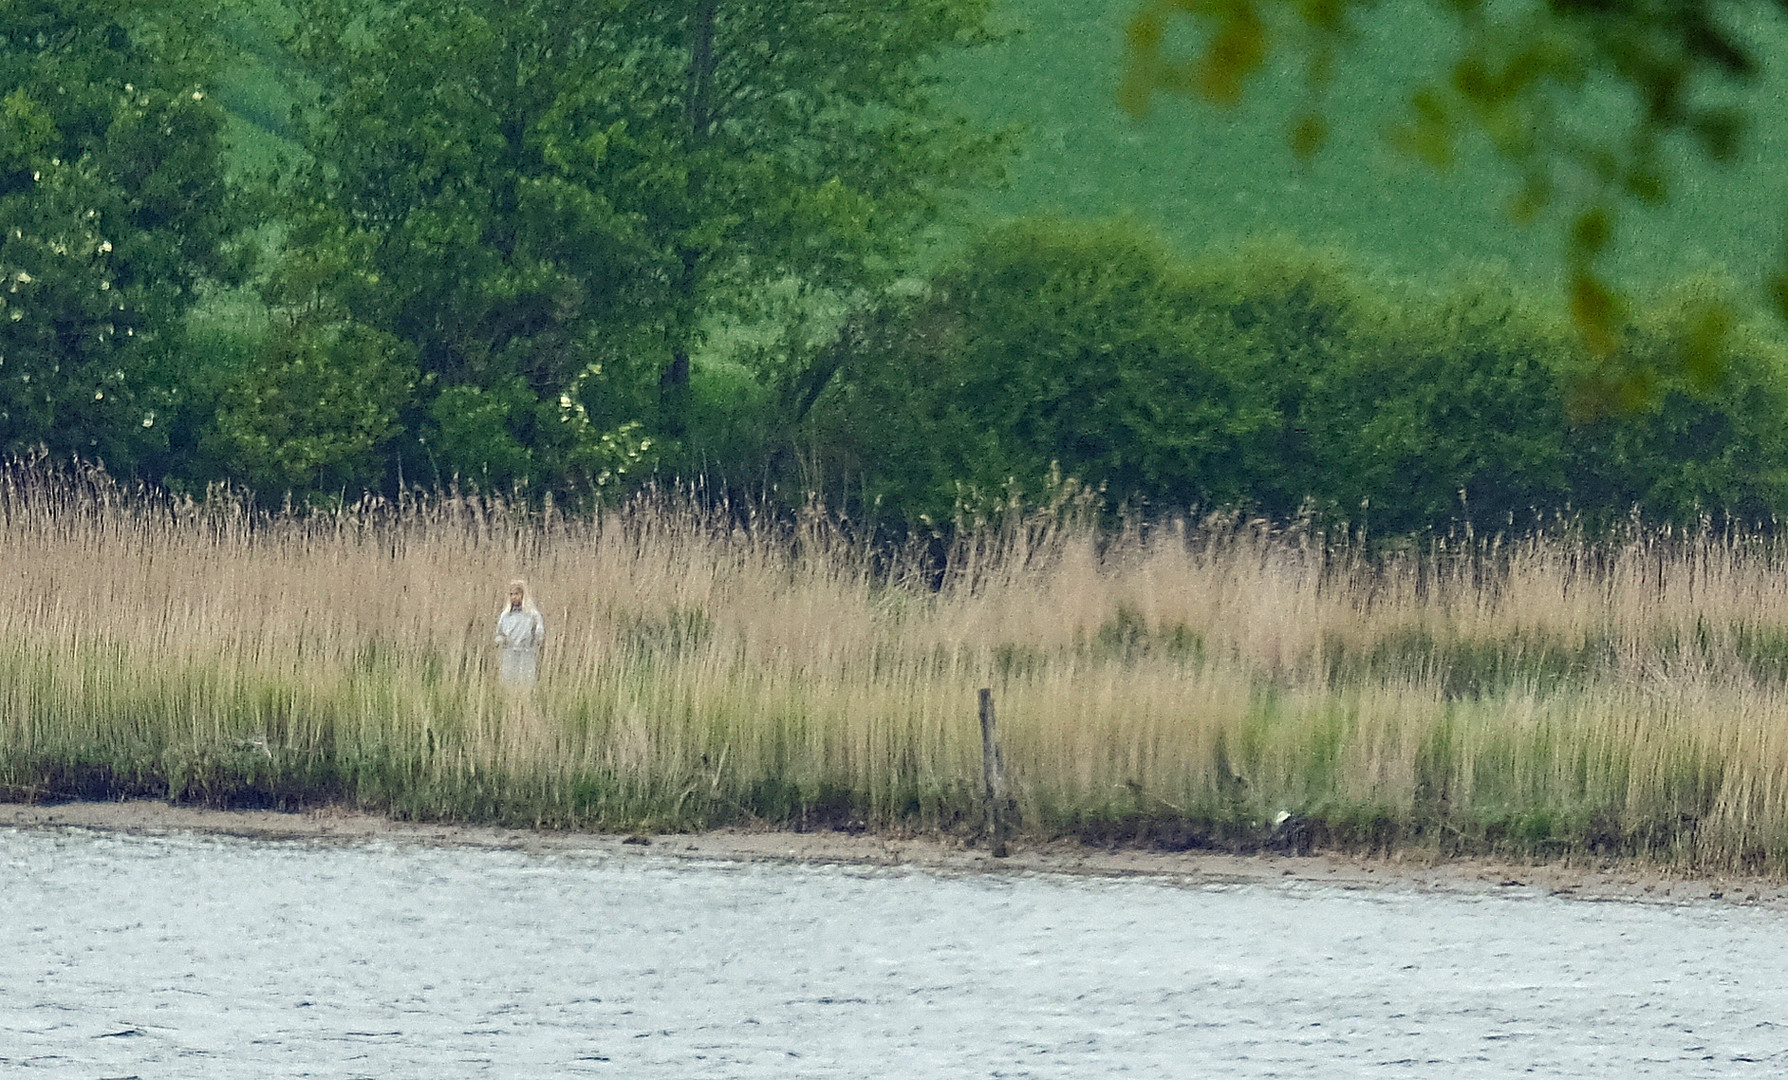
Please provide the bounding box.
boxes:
[948,0,1788,293]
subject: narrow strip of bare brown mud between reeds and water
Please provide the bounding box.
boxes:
[0,799,1788,910]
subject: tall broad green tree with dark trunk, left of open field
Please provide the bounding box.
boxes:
[280,0,994,493]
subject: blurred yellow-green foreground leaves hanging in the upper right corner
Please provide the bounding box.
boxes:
[1119,0,1788,379]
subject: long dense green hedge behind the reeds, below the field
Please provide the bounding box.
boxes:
[814,220,1788,533]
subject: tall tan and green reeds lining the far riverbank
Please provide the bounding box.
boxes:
[10,468,1788,873]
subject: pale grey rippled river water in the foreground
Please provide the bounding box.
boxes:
[0,830,1788,1080]
